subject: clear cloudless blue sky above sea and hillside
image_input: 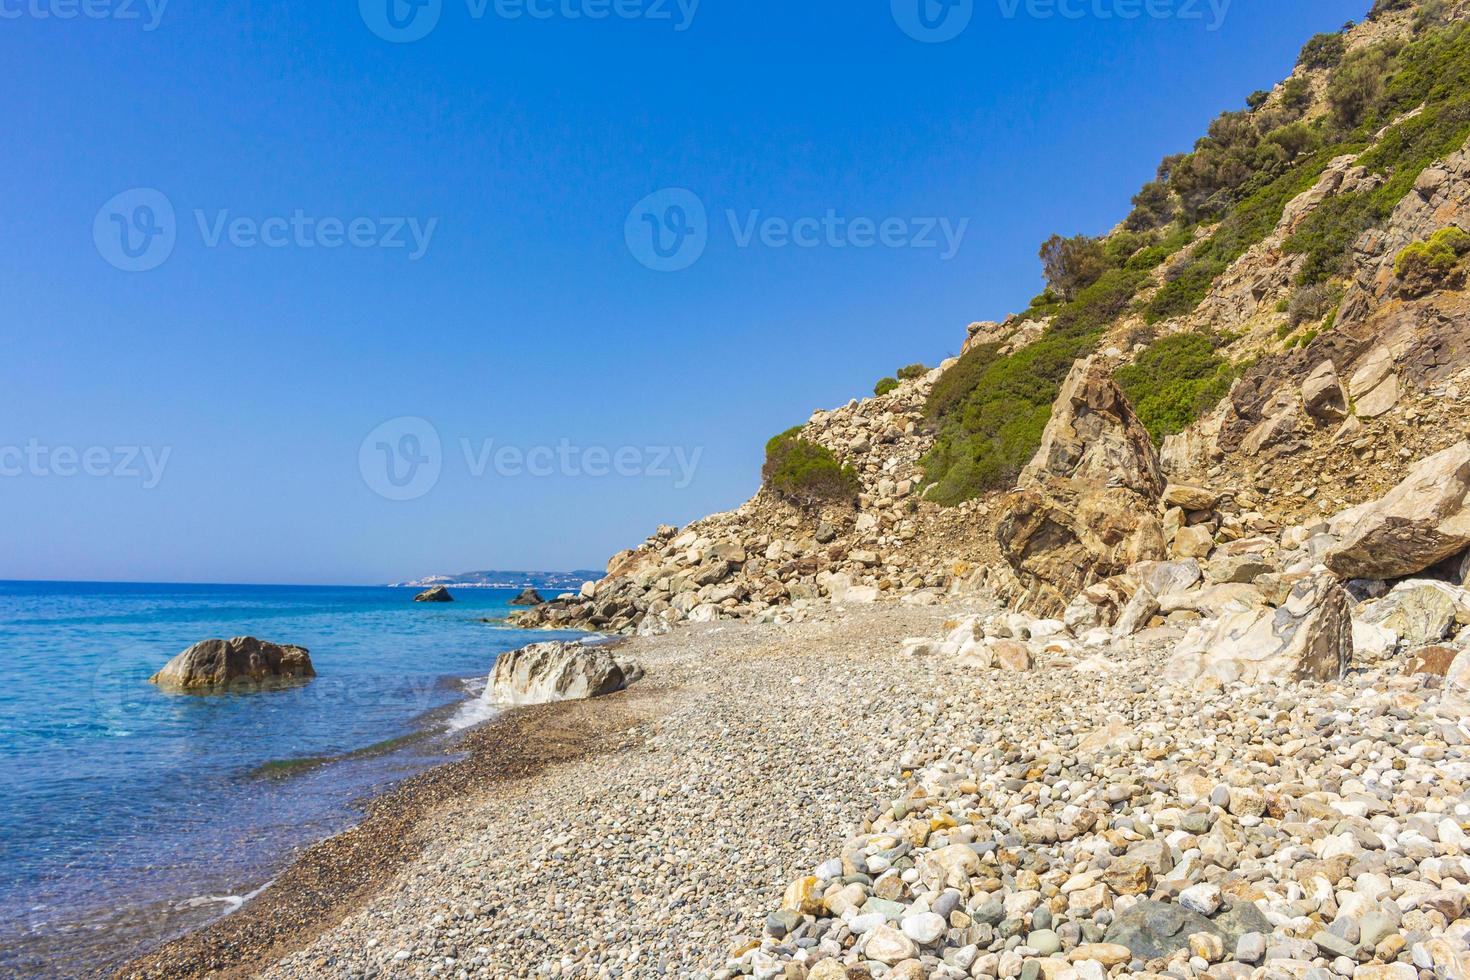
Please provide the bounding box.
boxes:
[0,0,1370,583]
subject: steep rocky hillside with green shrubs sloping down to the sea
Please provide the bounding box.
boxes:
[520,0,1470,633]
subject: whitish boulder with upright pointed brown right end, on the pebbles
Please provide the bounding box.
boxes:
[1164,574,1352,683]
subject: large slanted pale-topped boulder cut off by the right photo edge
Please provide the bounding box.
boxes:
[1326,439,1470,579]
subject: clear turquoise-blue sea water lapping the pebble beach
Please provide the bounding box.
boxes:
[0,582,579,977]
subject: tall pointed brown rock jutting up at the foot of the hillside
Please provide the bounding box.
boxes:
[997,359,1167,616]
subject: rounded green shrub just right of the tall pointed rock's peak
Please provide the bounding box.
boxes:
[1114,334,1238,442]
